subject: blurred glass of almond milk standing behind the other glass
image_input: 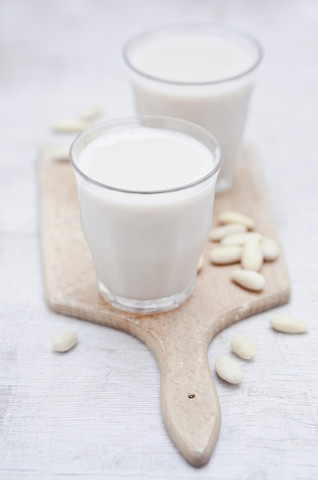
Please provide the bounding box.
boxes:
[124,23,262,191]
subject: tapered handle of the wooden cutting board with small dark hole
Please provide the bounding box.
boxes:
[155,335,221,466]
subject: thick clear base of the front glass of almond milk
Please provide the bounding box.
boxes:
[98,282,194,315]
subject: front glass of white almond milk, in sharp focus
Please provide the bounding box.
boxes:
[70,117,222,313]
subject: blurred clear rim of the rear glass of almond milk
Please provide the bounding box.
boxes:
[122,22,263,87]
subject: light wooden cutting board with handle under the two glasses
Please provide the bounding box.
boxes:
[39,142,290,466]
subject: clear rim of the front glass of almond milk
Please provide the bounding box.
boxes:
[69,115,223,195]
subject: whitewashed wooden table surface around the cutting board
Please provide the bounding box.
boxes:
[0,0,318,480]
